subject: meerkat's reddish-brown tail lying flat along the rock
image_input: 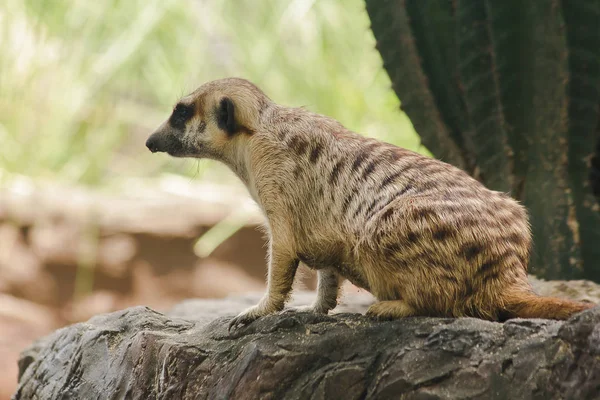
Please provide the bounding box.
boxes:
[505,293,596,320]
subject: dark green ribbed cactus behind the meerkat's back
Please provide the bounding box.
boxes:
[366,0,600,282]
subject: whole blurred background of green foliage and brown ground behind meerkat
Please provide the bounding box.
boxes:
[0,0,428,398]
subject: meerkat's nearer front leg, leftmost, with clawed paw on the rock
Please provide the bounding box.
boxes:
[229,244,299,330]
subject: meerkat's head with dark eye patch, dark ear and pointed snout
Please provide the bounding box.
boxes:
[146,78,271,161]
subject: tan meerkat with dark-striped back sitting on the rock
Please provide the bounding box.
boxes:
[146,78,593,329]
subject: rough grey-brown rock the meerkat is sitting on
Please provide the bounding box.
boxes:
[13,293,600,400]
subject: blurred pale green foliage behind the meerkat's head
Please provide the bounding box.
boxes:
[0,0,426,186]
